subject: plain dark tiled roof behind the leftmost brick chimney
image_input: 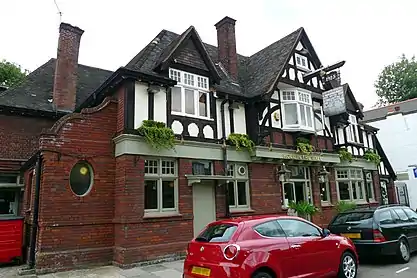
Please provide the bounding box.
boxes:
[0,58,112,112]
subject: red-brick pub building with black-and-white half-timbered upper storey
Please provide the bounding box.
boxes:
[13,17,396,272]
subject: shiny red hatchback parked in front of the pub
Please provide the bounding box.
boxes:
[183,216,358,278]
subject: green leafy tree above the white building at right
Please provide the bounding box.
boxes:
[375,54,417,106]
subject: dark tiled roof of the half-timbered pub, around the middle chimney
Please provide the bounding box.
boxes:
[126,26,308,97]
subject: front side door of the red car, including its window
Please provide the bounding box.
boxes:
[277,218,336,278]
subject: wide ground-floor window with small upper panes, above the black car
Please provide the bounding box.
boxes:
[336,169,365,201]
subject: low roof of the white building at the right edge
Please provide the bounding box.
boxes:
[362,98,417,122]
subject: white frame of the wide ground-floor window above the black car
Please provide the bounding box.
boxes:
[335,168,366,203]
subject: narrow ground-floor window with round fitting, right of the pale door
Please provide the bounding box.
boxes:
[227,164,250,210]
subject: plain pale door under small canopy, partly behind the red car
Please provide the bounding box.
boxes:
[193,181,216,236]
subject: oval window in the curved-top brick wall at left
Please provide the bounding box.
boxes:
[70,161,93,196]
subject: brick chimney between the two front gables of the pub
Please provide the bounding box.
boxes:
[214,16,237,79]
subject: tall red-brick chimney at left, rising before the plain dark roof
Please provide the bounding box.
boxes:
[53,23,84,112]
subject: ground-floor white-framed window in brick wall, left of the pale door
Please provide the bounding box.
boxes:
[145,159,178,213]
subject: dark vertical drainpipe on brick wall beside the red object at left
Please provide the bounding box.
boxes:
[29,153,42,268]
